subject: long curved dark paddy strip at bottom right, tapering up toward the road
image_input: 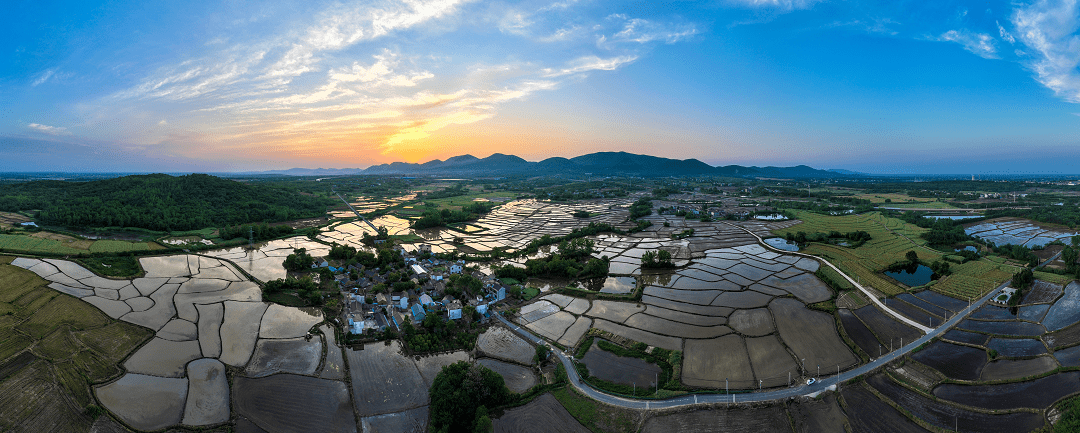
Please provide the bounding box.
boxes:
[866,374,1044,433]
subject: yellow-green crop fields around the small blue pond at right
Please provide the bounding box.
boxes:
[773,212,1018,299]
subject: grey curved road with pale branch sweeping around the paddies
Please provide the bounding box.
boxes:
[495,222,1009,409]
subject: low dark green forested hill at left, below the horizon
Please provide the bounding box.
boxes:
[0,174,329,230]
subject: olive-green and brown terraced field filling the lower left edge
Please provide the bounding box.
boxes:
[0,259,153,431]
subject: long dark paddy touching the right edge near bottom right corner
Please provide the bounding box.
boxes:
[931,371,1080,410]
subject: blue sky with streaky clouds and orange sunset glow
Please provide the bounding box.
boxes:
[0,0,1080,174]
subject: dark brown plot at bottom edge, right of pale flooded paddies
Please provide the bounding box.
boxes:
[232,374,356,432]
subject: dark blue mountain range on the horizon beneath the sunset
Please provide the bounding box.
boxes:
[250,152,862,178]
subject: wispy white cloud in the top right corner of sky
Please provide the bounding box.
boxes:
[1012,0,1080,104]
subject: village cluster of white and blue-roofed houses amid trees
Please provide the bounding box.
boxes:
[328,245,507,334]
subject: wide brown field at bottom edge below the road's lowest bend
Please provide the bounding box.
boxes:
[642,406,792,433]
